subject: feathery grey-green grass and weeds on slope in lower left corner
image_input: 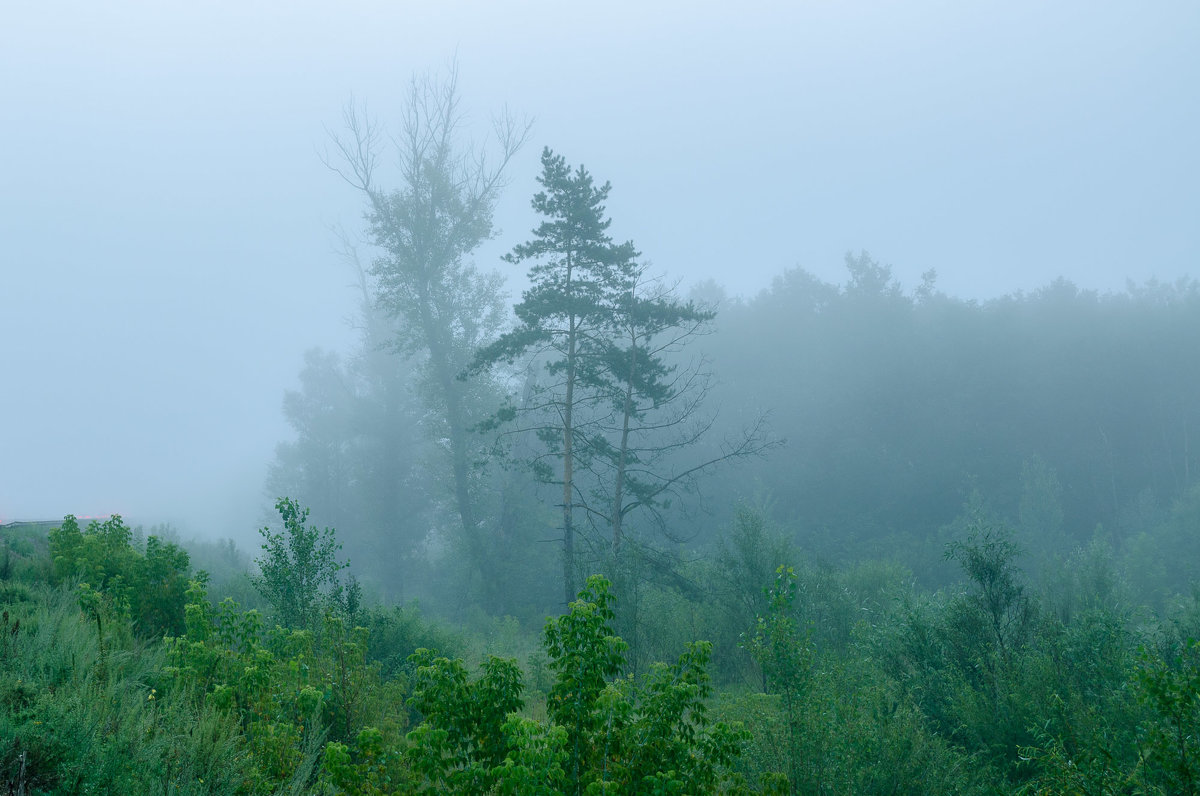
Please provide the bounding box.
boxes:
[0,586,252,795]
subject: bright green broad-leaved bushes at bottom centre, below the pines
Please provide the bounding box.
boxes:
[324,576,750,795]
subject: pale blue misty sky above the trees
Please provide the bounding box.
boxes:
[0,0,1200,535]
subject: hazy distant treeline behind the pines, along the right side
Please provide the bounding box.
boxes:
[697,253,1200,573]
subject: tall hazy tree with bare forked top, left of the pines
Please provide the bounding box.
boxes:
[331,67,528,578]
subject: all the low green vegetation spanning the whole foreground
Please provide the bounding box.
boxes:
[0,501,1200,795]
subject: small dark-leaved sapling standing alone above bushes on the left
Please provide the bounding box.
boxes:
[253,497,347,628]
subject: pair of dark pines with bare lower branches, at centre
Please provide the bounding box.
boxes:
[473,149,770,602]
